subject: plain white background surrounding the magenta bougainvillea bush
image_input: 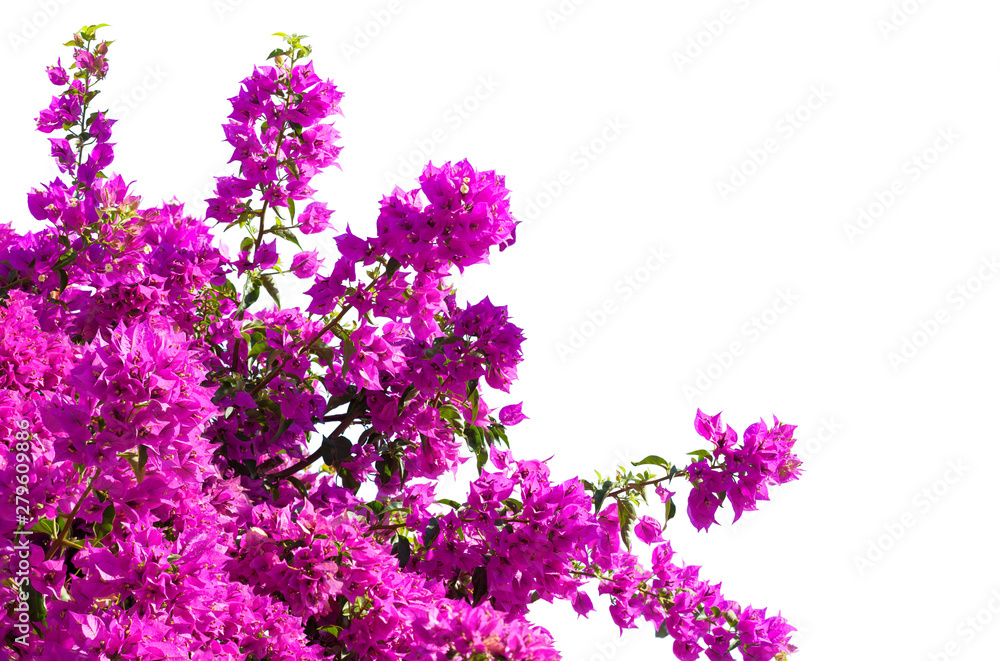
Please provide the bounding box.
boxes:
[0,0,1000,661]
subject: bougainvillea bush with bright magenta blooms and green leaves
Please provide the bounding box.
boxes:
[0,26,799,661]
